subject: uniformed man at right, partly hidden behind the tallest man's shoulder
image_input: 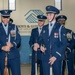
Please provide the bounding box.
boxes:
[56,15,74,75]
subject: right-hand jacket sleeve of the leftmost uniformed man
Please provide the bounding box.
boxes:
[12,26,21,48]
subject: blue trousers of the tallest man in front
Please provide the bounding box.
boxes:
[42,60,62,75]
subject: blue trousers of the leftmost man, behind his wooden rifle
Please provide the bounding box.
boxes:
[0,58,21,75]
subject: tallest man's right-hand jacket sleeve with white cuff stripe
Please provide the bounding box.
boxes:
[53,26,67,59]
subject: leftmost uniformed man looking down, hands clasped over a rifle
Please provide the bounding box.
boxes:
[0,10,21,75]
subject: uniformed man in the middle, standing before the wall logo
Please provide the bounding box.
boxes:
[29,15,47,75]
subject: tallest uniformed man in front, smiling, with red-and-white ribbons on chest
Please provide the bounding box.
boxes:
[40,6,67,75]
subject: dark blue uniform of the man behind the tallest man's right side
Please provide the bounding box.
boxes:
[62,29,74,75]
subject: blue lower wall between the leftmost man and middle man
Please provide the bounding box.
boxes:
[20,36,32,63]
